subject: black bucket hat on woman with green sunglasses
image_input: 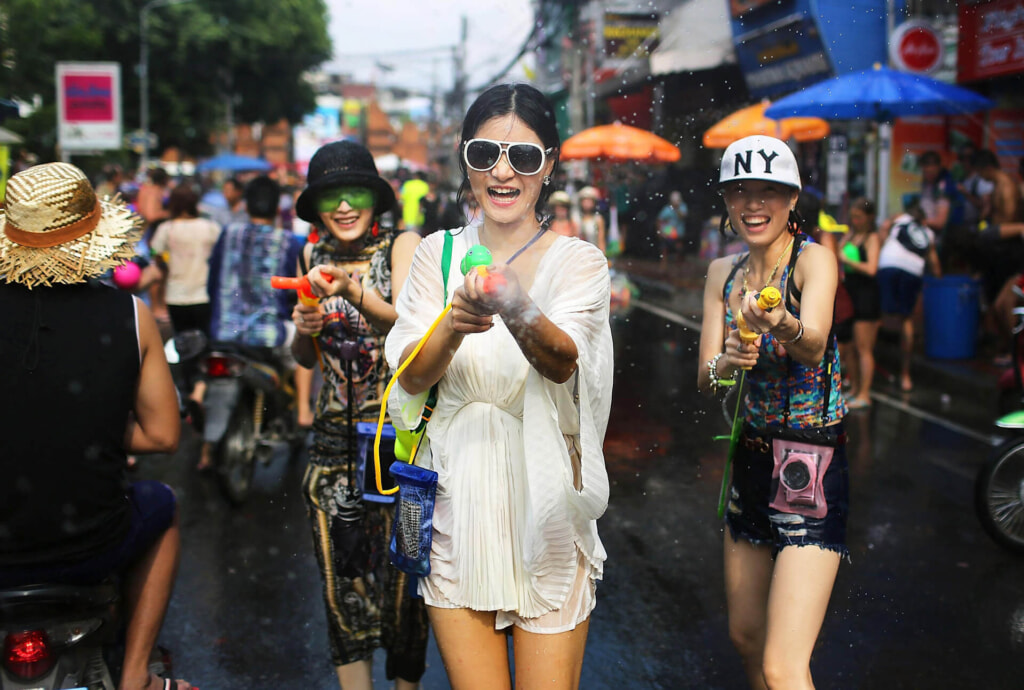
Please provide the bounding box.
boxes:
[295,141,395,223]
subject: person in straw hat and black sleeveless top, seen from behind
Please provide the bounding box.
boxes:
[0,163,191,690]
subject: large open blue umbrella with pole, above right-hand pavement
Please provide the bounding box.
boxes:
[765,64,993,213]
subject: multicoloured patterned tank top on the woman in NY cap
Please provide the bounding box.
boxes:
[723,239,847,429]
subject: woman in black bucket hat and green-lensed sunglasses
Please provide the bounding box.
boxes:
[292,141,427,690]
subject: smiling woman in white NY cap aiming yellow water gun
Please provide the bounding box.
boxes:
[697,136,849,690]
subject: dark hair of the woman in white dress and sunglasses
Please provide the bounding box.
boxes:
[458,84,561,218]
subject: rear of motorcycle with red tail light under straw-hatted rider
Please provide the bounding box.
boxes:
[0,580,120,690]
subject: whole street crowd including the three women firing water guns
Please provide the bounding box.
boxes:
[8,76,1024,690]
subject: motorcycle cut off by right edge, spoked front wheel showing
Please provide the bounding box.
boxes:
[974,303,1024,554]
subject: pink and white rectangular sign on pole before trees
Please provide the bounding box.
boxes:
[56,62,123,152]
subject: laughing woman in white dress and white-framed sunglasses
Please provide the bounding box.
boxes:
[385,84,612,690]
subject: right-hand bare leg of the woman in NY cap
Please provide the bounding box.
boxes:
[764,547,840,690]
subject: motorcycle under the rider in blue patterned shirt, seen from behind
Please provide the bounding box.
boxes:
[200,343,305,505]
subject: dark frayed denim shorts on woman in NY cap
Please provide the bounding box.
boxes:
[725,424,850,558]
